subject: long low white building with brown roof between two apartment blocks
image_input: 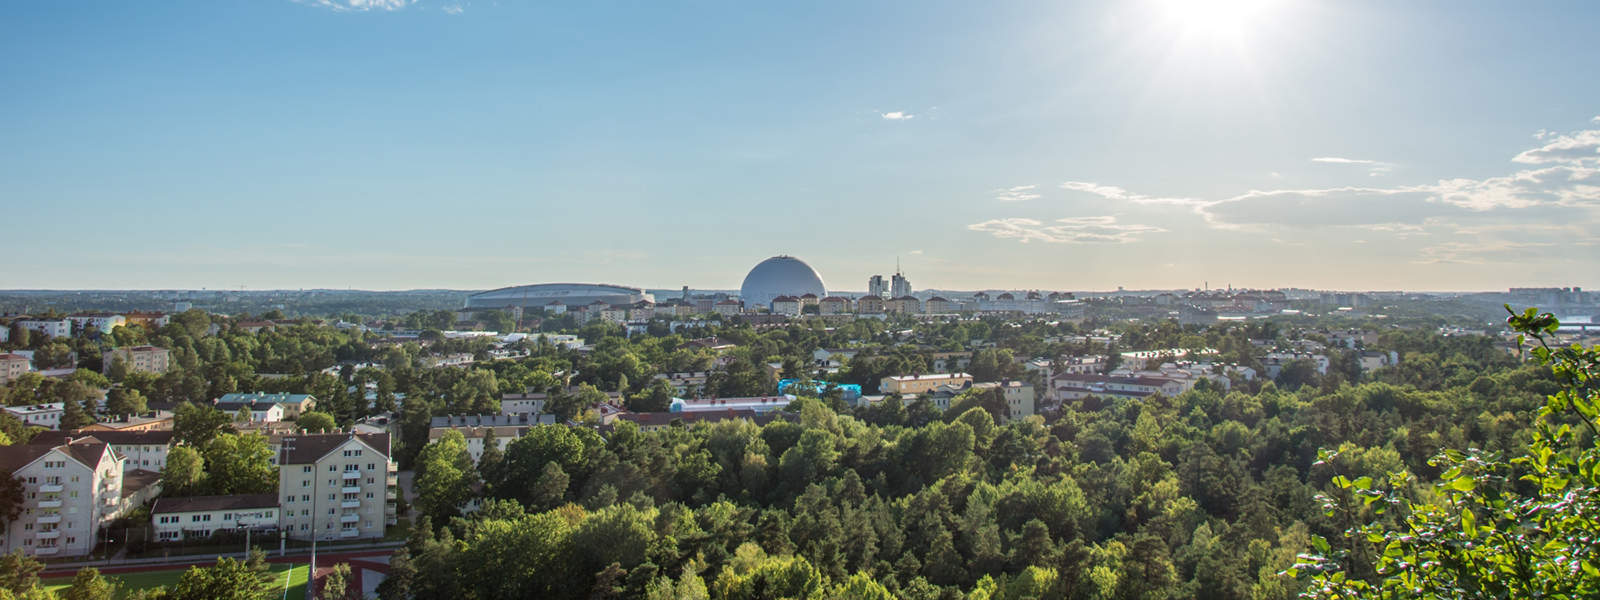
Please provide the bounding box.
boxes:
[150,494,278,542]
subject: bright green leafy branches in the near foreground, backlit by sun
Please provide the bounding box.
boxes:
[1288,306,1600,598]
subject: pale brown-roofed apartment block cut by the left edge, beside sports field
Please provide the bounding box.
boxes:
[0,442,122,557]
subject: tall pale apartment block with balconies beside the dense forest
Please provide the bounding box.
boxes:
[278,434,397,539]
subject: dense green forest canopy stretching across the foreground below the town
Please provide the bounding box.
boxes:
[387,312,1592,598]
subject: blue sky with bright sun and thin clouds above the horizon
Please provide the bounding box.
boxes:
[0,0,1600,290]
